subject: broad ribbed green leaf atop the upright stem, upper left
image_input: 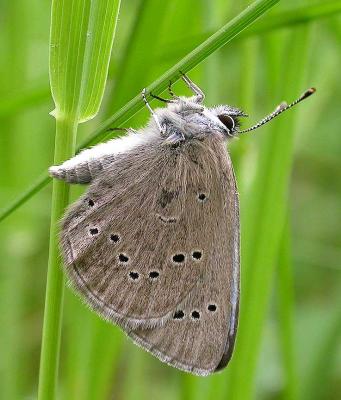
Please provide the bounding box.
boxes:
[50,0,120,122]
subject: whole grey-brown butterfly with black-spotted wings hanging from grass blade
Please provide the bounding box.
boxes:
[49,75,314,375]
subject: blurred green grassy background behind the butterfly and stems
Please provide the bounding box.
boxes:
[0,0,341,400]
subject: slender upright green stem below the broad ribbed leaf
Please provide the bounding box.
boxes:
[38,115,77,400]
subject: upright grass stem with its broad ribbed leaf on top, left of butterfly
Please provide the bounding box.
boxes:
[38,0,119,400]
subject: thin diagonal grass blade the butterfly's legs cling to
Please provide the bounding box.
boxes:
[0,0,279,221]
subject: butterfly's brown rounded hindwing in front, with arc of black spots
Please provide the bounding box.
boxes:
[61,133,236,328]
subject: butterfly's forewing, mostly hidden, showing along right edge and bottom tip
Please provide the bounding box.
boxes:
[127,145,239,375]
